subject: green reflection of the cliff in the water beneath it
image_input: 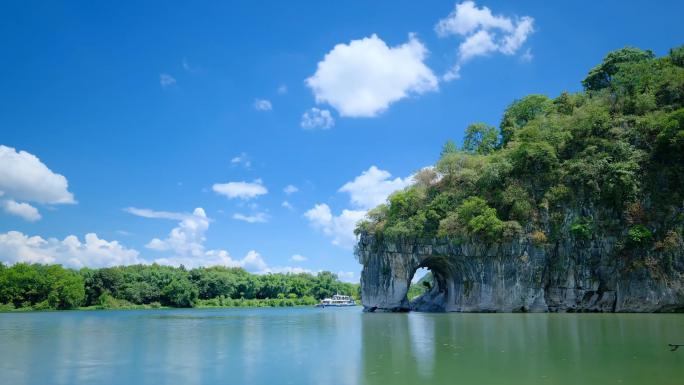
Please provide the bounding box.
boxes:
[361,313,684,385]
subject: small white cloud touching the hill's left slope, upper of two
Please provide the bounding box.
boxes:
[339,166,411,210]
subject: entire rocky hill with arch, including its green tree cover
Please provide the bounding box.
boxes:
[356,47,684,312]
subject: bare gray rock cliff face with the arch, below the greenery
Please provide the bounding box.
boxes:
[356,235,684,312]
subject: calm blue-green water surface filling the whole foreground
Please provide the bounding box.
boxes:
[0,308,684,385]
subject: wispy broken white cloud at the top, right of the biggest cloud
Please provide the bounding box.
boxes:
[435,1,534,80]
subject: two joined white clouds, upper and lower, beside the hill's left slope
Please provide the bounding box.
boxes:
[304,166,412,249]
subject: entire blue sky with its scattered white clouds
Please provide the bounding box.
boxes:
[0,1,684,280]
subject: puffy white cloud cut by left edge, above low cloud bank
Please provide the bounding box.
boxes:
[0,145,76,221]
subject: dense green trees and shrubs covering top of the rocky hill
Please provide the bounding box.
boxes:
[356,46,684,269]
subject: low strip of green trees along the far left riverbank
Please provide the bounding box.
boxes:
[0,263,358,310]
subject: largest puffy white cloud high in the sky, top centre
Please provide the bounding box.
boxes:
[306,34,438,117]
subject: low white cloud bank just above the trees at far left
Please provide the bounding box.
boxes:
[0,231,145,268]
